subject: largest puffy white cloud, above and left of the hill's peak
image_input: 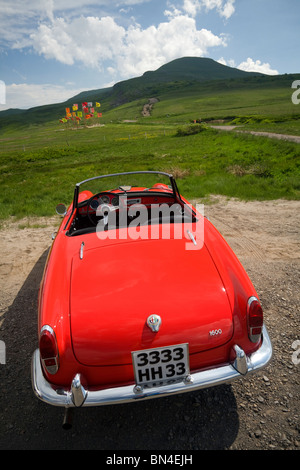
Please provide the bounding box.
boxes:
[30,14,226,78]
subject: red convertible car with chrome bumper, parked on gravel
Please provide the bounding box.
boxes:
[32,171,272,426]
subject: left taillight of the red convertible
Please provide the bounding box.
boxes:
[39,325,59,374]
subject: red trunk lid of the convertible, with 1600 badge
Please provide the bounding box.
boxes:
[70,240,233,366]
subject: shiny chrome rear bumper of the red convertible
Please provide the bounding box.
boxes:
[32,326,272,408]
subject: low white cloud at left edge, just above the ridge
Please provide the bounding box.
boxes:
[0,83,83,112]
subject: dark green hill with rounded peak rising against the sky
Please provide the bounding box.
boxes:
[0,57,299,128]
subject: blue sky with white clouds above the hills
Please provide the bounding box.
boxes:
[0,0,300,110]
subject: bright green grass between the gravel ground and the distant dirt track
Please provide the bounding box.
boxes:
[0,120,300,220]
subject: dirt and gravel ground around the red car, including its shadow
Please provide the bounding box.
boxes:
[0,198,300,452]
